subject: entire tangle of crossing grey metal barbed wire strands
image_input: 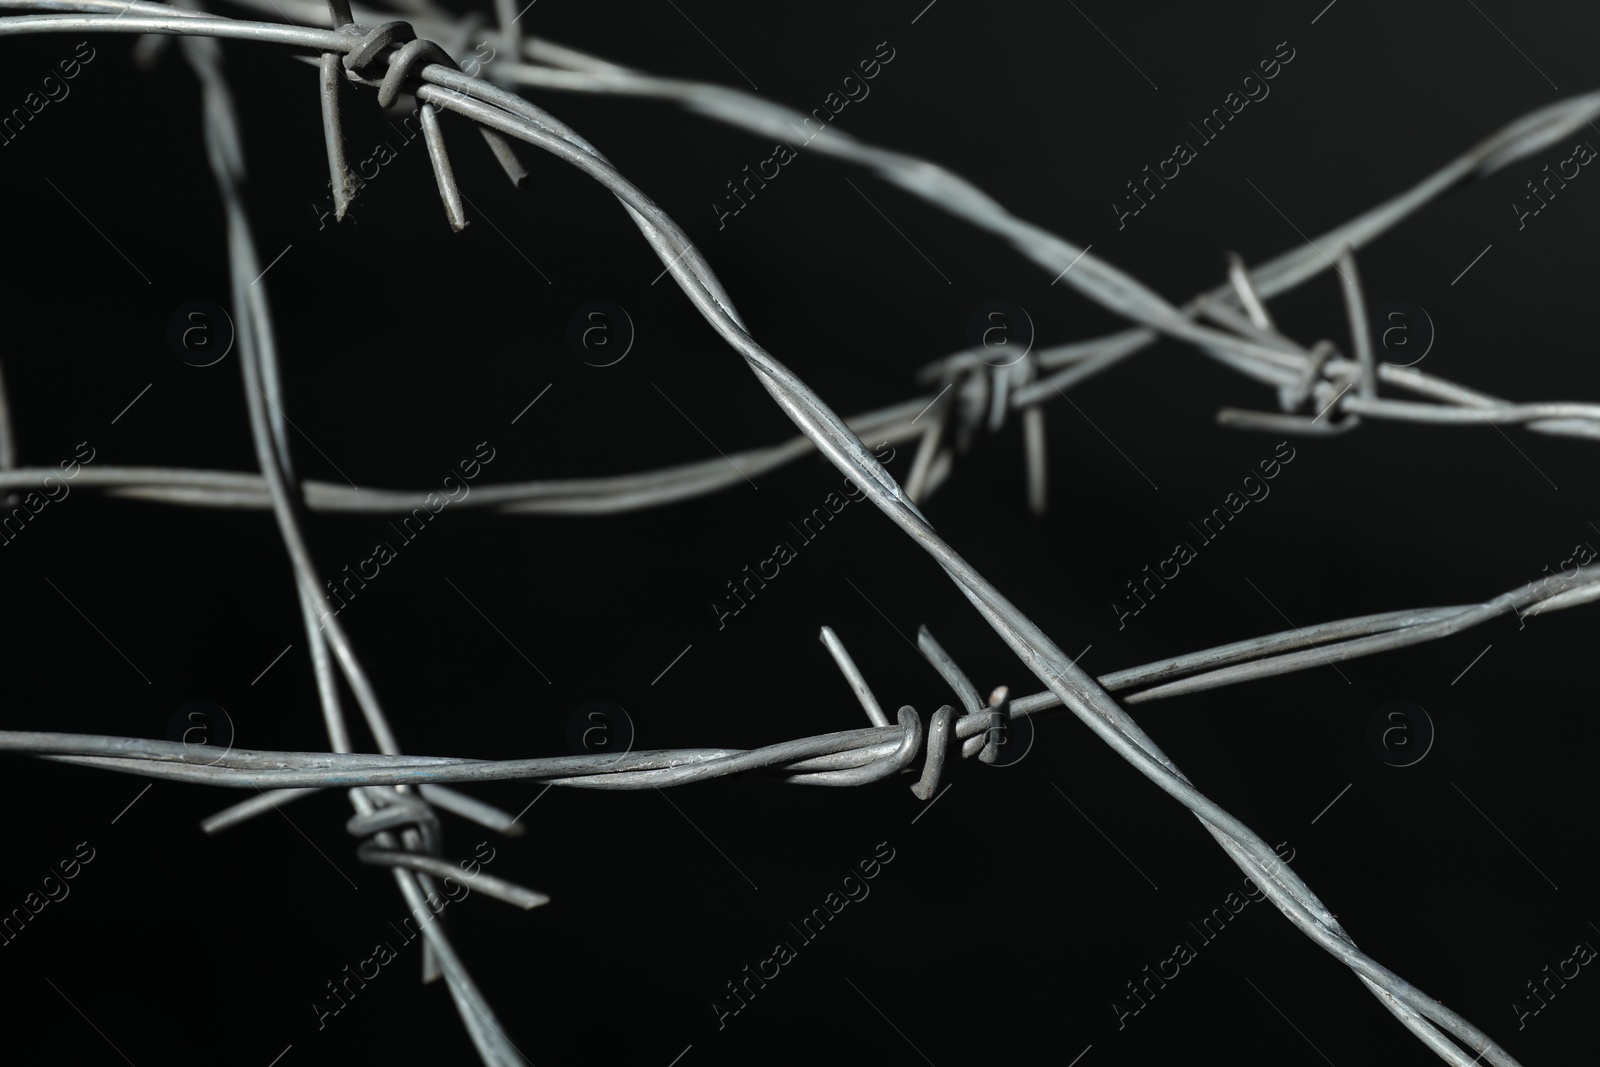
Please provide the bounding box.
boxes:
[0,0,1600,1065]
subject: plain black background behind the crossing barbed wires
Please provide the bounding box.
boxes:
[0,0,1600,1067]
